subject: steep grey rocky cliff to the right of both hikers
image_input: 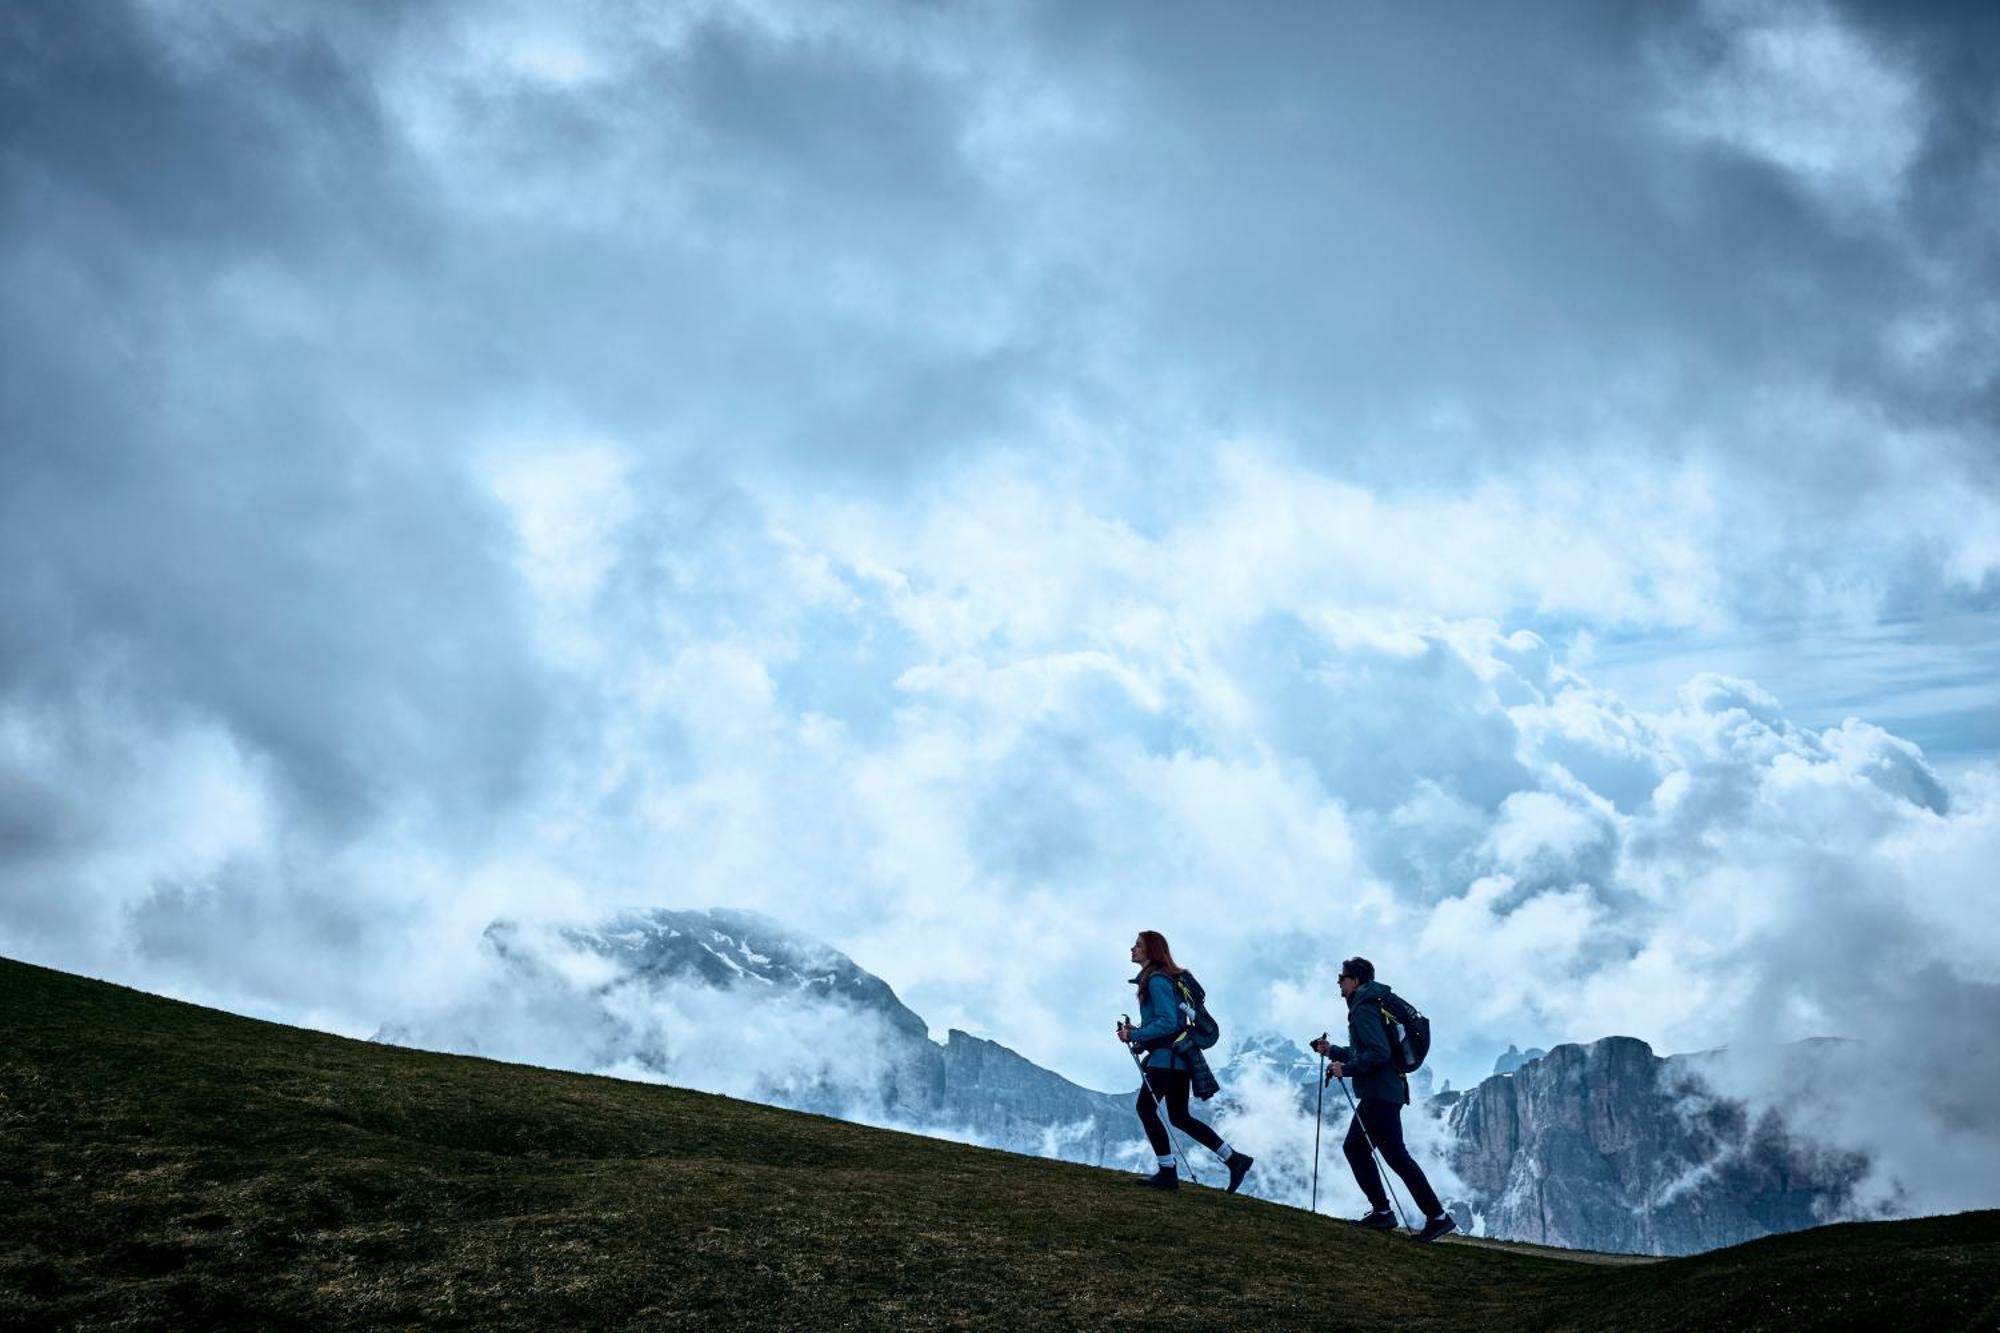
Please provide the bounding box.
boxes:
[1442,1037,1866,1255]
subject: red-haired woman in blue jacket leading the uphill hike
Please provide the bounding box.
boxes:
[1118,931,1254,1195]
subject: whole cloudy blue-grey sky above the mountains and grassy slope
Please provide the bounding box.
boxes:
[0,0,2000,1207]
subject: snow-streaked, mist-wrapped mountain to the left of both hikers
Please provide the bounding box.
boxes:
[376,909,1132,1163]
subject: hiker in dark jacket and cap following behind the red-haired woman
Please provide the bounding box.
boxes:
[1312,959,1458,1241]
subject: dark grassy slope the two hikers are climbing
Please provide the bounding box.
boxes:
[0,961,2000,1329]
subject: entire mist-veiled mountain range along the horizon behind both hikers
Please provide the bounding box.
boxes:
[376,896,1882,1253]
